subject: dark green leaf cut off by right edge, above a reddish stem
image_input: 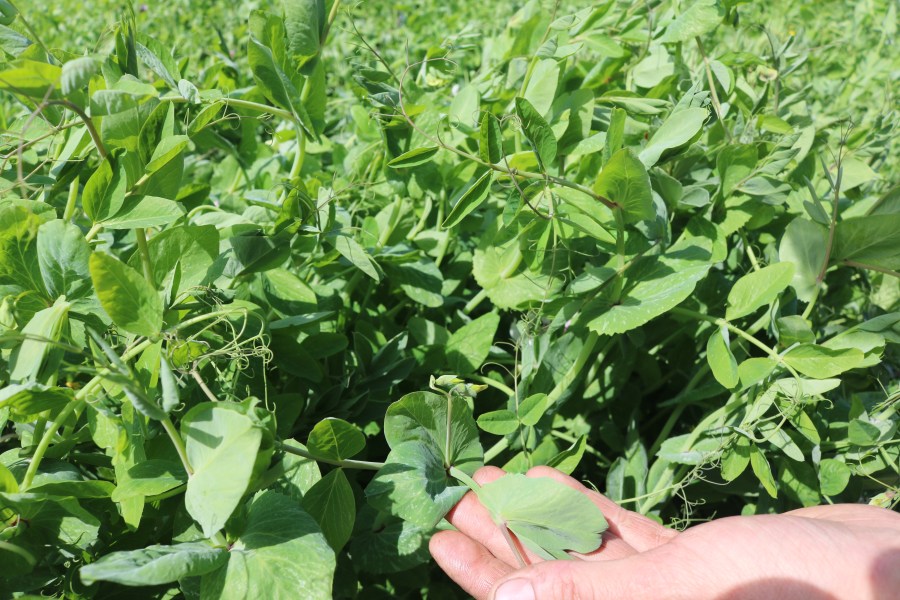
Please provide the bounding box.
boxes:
[832,213,900,271]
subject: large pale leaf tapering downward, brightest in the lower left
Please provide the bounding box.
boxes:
[181,402,262,537]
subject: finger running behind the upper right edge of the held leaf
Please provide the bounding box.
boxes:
[528,467,678,554]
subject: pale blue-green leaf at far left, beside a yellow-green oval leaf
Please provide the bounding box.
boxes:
[37,219,91,300]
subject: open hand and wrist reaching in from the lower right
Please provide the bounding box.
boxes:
[430,467,900,600]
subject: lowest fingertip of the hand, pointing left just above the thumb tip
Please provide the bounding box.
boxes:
[428,531,513,600]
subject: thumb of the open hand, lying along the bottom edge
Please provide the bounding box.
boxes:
[490,555,672,600]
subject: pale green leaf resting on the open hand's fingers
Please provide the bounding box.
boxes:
[475,473,607,560]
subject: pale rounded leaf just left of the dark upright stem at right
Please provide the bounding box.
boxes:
[778,217,828,302]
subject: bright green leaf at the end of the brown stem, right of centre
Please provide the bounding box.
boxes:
[594,148,656,223]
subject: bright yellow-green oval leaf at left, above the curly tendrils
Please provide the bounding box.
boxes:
[90,252,163,337]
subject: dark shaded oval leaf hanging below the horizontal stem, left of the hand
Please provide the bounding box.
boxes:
[303,469,356,552]
